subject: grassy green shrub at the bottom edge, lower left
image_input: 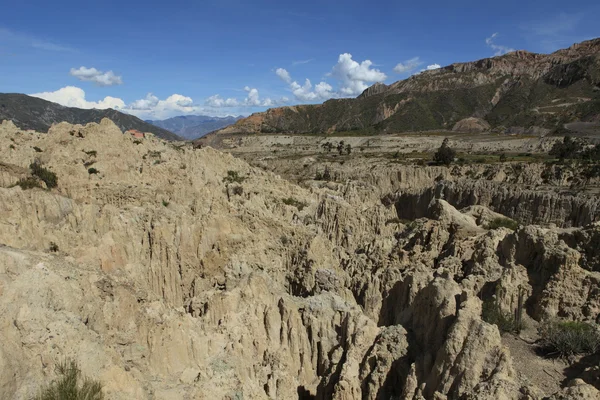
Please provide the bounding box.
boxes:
[34,361,104,400]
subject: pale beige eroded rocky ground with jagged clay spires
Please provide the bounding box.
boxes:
[0,120,600,399]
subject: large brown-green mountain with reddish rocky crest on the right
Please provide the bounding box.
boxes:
[210,39,600,134]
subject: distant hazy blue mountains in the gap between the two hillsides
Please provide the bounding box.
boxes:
[146,115,243,140]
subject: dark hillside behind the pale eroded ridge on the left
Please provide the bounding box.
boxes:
[0,93,181,140]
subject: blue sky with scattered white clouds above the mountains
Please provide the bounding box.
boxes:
[0,0,600,119]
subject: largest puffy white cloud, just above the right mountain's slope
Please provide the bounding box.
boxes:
[330,53,387,96]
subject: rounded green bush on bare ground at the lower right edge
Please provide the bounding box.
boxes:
[538,320,600,357]
